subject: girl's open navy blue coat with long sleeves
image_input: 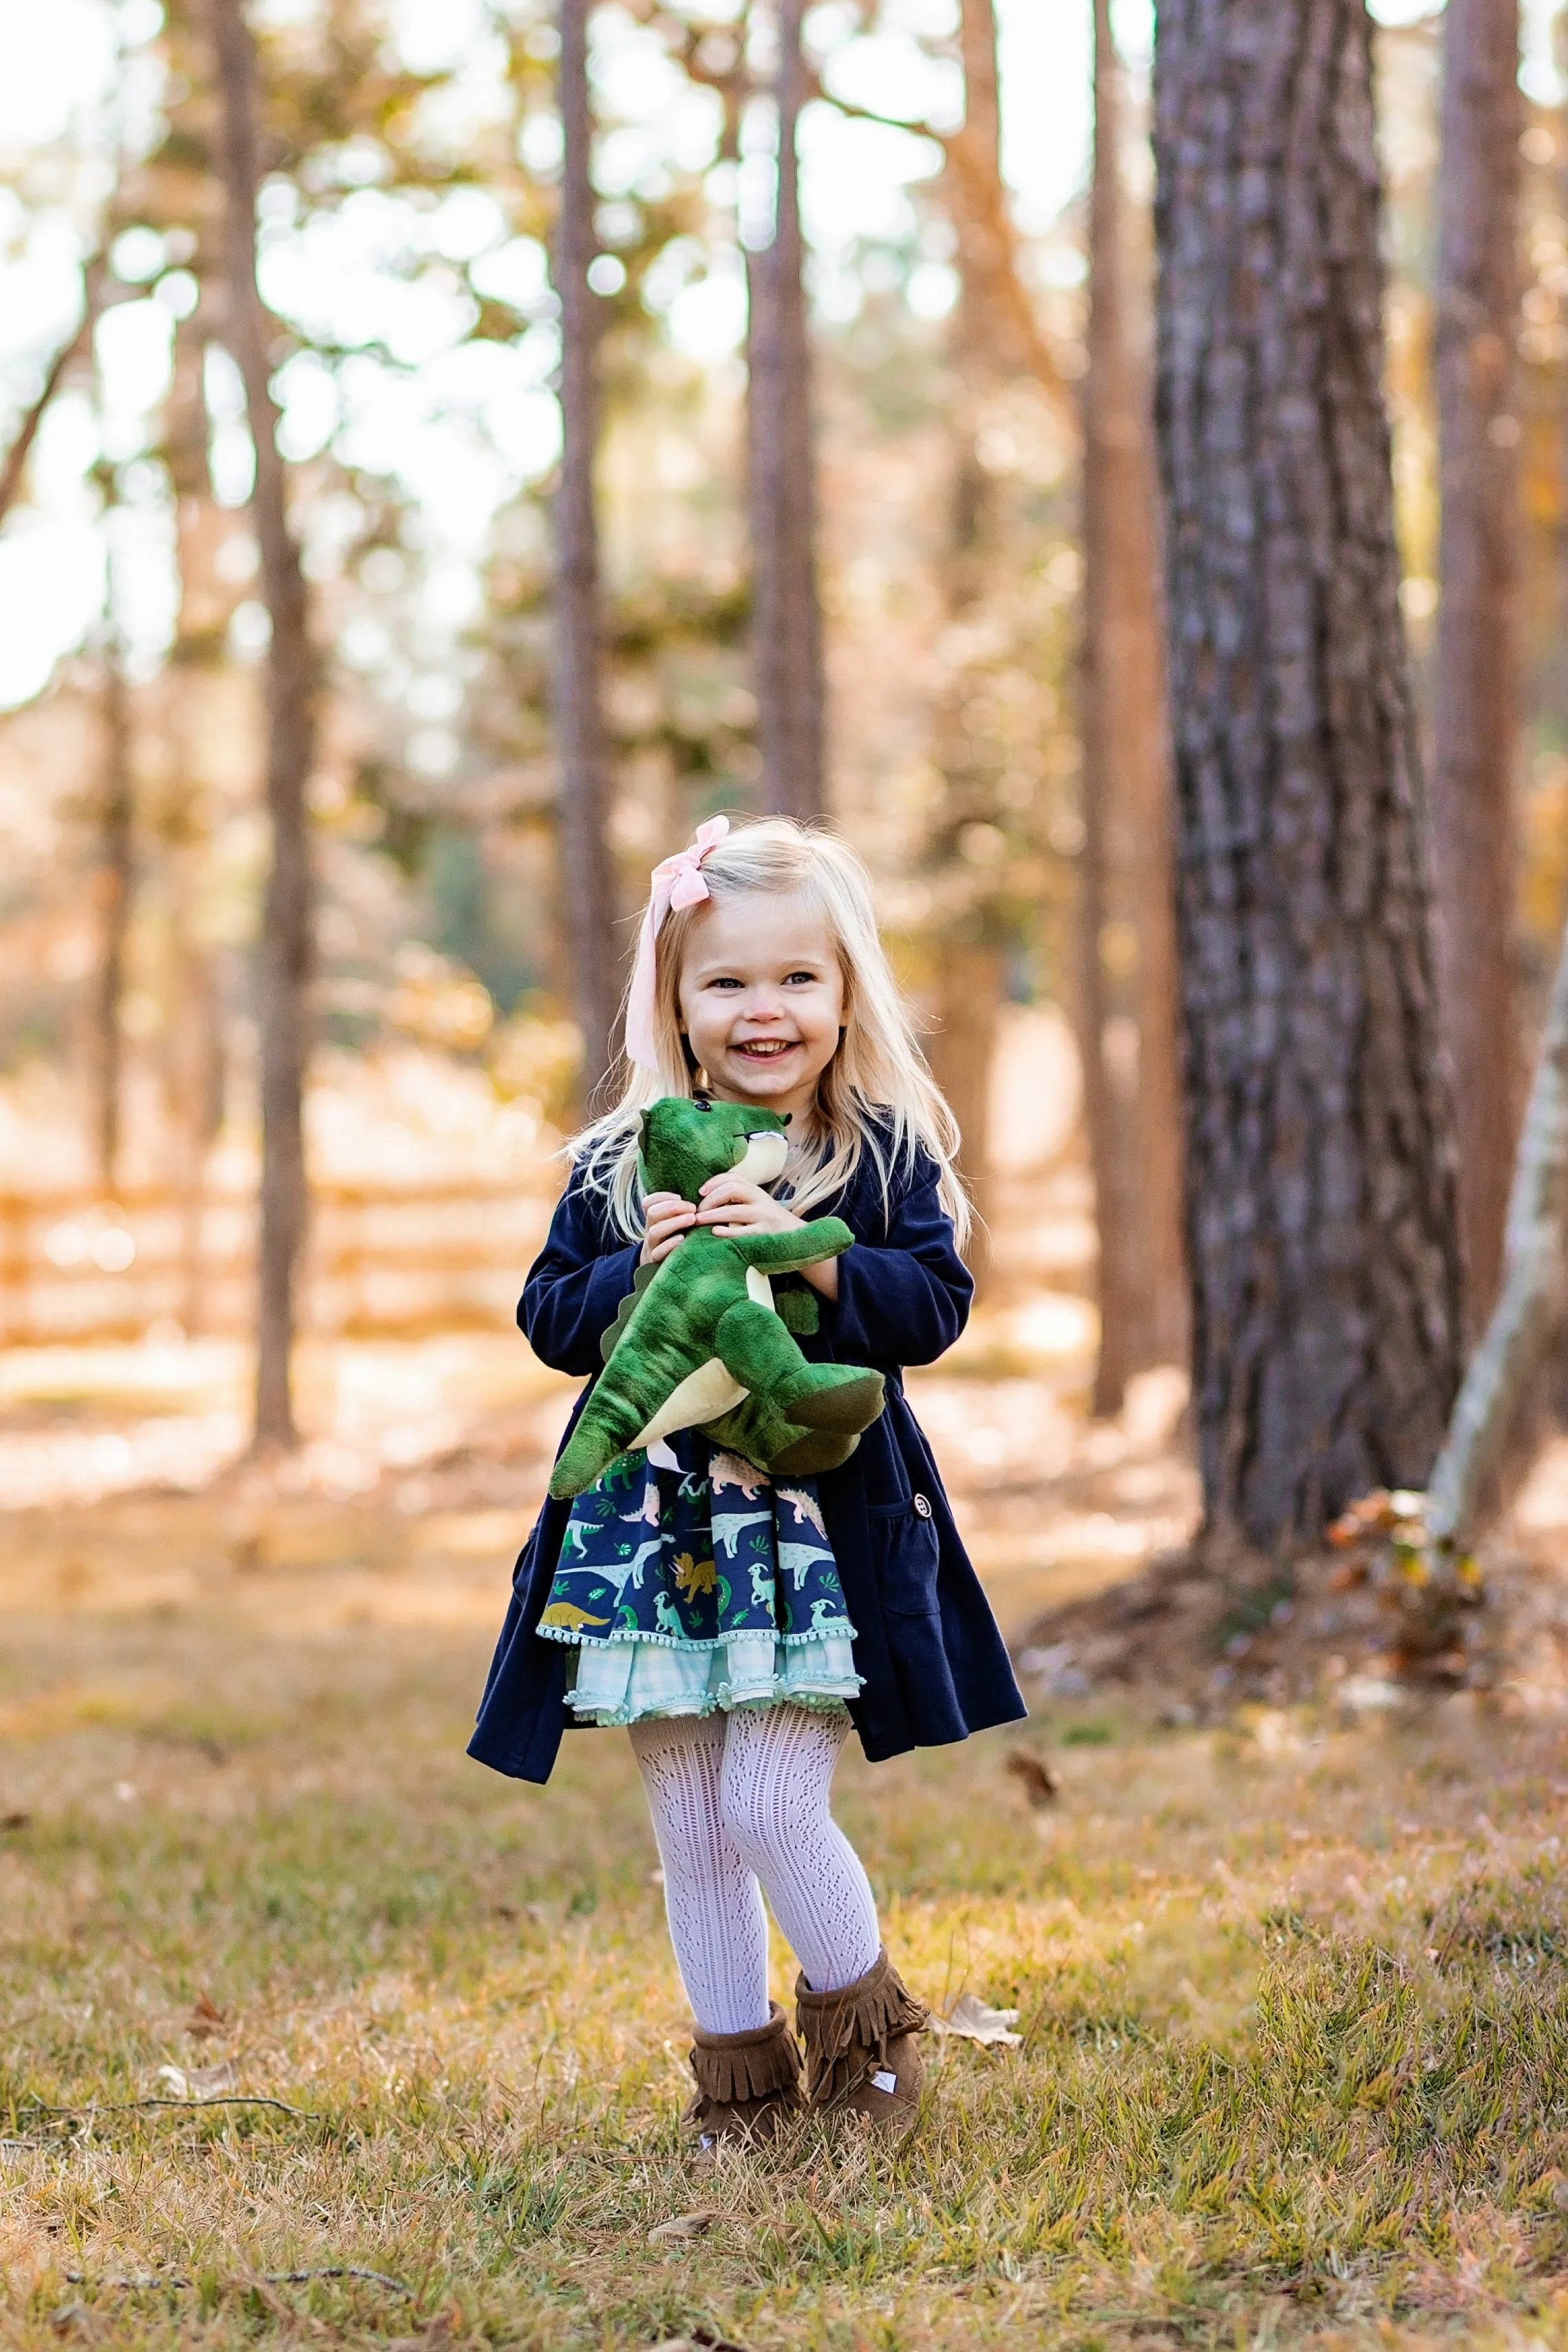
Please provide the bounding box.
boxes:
[468,1155,1027,1781]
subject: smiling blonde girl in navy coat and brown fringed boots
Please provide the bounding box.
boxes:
[468,816,1025,2150]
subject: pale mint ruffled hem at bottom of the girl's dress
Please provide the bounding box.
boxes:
[566,1630,862,1726]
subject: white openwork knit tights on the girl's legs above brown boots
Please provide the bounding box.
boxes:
[633,1708,882,2035]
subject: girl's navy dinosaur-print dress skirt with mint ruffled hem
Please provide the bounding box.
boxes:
[538,1432,860,1724]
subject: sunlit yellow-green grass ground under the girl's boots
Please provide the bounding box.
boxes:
[0,1467,1568,2352]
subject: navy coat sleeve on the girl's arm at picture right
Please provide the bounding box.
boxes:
[827,1153,975,1364]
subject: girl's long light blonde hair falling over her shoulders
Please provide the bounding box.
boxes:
[569,816,971,1242]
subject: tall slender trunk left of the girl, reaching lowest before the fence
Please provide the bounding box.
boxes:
[209,0,317,1449]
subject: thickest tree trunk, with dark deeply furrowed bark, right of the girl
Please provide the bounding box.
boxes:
[1154,0,1460,1543]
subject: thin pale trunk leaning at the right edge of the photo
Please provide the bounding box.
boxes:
[1427,907,1568,1550]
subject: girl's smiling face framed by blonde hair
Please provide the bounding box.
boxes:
[677,892,844,1115]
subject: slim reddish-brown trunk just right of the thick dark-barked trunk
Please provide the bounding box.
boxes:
[1432,0,1523,1334]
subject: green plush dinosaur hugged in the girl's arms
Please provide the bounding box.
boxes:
[550,1096,882,1496]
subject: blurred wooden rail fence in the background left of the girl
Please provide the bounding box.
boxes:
[0,1178,553,1347]
